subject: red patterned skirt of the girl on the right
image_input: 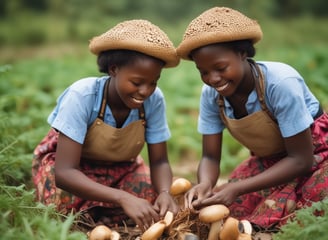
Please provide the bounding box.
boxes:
[229,113,328,229]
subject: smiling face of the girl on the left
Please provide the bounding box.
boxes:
[109,56,163,109]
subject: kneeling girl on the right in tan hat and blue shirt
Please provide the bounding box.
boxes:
[177,7,328,228]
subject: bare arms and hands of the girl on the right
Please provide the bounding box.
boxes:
[186,129,313,209]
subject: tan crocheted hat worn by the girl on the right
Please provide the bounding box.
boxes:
[177,7,262,60]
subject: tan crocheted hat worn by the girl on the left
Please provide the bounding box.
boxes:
[89,20,179,68]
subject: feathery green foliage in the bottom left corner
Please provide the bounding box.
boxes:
[0,184,87,240]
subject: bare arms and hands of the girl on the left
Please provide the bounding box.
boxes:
[55,133,177,230]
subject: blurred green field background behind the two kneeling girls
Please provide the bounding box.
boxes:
[0,0,328,239]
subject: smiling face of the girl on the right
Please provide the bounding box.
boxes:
[191,44,249,97]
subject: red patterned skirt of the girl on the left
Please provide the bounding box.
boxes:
[32,129,157,225]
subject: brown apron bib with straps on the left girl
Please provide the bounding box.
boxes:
[82,80,145,164]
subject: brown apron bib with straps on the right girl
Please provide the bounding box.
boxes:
[218,62,286,157]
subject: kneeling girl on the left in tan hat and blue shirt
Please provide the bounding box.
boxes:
[32,20,179,229]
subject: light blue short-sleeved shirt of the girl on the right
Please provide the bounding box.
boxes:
[198,62,319,137]
